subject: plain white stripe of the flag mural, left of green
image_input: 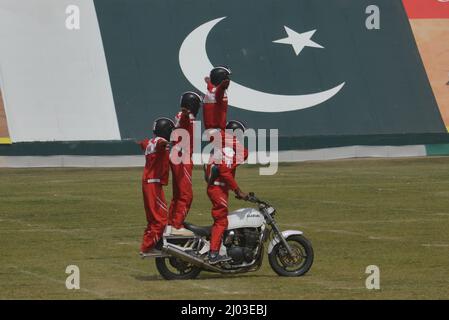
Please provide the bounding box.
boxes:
[0,0,120,142]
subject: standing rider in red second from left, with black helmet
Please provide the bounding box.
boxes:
[168,92,202,235]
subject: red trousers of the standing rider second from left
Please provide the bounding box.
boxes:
[168,163,193,229]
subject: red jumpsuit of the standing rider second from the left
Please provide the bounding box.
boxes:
[168,112,195,229]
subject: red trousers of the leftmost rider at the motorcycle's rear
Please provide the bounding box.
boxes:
[140,182,168,252]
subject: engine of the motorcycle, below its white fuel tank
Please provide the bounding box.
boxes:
[224,228,260,264]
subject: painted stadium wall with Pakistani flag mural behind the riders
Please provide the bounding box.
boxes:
[0,0,449,166]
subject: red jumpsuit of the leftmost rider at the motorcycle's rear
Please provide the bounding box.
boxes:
[140,137,169,252]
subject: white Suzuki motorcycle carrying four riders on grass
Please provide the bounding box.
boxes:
[145,193,314,280]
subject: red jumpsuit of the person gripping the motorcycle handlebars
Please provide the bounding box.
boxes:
[206,140,248,251]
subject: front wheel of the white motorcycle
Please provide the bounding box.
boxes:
[268,235,313,277]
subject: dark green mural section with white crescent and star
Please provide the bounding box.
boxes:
[95,0,446,138]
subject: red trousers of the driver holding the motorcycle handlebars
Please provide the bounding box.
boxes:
[207,185,229,251]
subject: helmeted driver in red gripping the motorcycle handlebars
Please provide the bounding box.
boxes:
[206,120,248,264]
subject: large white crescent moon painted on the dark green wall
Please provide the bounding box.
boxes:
[179,17,345,112]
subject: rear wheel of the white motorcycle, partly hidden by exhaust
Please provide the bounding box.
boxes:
[156,243,201,280]
